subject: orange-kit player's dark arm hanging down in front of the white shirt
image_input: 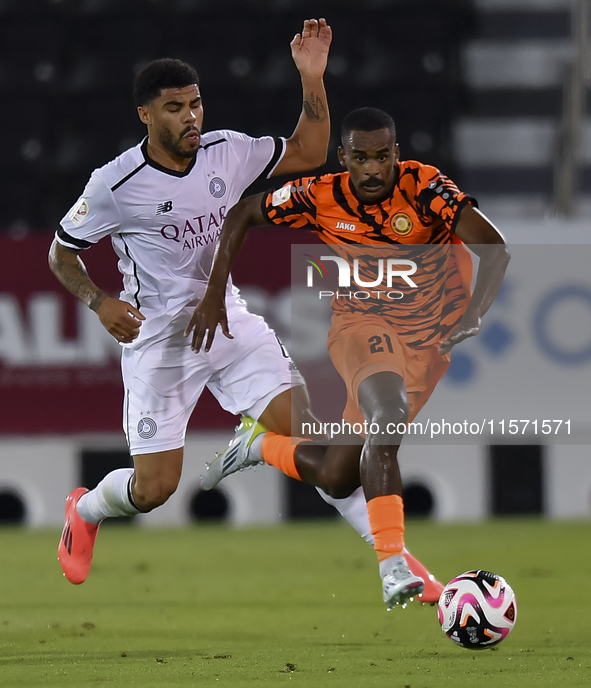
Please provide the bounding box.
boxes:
[185,194,265,353]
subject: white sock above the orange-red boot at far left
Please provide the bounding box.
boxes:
[76,468,141,523]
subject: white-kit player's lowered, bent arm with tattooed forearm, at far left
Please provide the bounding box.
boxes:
[49,239,146,343]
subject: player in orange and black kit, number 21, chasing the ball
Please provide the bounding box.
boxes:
[187,108,509,608]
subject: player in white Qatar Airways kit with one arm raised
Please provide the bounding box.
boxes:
[49,19,331,584]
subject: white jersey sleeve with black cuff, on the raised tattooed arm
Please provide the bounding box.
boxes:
[224,131,286,188]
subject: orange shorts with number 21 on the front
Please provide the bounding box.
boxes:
[328,313,451,424]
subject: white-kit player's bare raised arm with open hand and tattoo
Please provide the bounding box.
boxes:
[272,19,332,176]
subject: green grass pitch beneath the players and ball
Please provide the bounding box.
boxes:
[0,519,591,688]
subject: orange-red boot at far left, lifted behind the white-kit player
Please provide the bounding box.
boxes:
[57,487,99,585]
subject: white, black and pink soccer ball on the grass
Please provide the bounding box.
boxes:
[437,571,517,650]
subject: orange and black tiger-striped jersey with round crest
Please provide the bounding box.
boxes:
[262,160,476,346]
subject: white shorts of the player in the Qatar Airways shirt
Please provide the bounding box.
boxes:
[121,300,305,456]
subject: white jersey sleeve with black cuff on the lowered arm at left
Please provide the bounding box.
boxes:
[56,170,121,250]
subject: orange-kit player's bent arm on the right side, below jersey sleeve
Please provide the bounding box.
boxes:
[439,205,510,354]
